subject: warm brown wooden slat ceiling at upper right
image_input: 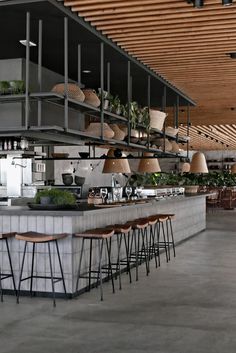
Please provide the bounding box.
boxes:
[64,0,236,148]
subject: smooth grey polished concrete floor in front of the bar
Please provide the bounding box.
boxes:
[0,211,236,353]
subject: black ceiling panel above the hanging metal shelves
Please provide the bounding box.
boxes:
[0,1,192,107]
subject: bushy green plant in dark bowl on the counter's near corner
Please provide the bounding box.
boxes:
[34,189,76,205]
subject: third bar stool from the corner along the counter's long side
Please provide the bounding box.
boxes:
[126,218,150,281]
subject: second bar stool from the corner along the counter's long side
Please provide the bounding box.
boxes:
[106,224,132,289]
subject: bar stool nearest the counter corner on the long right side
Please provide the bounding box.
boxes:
[74,228,115,301]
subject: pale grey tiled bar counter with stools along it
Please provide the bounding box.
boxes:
[0,195,206,295]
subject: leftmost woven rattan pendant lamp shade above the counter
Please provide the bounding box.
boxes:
[102,149,131,174]
